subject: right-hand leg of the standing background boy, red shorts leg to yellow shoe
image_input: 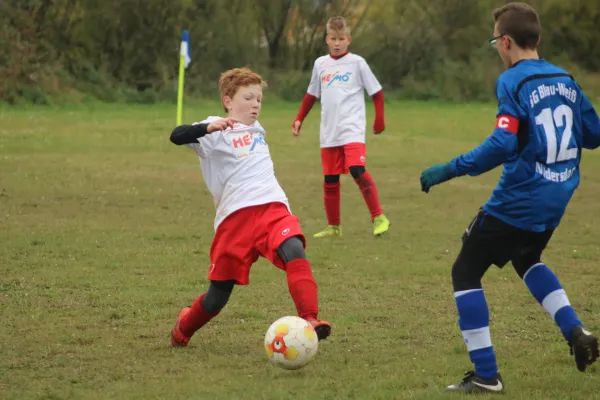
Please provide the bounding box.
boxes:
[344,143,390,236]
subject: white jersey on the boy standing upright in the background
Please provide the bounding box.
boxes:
[307,53,381,147]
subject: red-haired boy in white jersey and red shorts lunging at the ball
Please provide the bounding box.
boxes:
[171,68,331,347]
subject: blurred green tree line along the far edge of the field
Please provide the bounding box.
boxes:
[0,0,600,103]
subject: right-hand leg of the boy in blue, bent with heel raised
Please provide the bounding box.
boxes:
[512,231,600,372]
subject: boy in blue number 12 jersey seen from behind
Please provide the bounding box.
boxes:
[421,3,600,393]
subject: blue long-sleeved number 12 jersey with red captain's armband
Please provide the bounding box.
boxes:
[450,59,600,232]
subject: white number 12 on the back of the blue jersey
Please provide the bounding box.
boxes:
[535,104,578,164]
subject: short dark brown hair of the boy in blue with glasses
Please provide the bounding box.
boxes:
[492,3,542,49]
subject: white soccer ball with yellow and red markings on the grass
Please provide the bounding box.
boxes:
[265,317,319,370]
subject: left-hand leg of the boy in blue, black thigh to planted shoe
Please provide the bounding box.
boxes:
[446,211,504,393]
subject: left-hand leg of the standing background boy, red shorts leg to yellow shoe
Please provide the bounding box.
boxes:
[314,147,344,238]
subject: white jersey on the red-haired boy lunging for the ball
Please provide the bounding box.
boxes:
[187,117,289,231]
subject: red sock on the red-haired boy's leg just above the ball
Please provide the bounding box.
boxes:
[285,258,319,319]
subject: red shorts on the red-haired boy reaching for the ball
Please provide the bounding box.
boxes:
[208,202,306,285]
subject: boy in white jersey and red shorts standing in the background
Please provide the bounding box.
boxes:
[292,17,390,238]
